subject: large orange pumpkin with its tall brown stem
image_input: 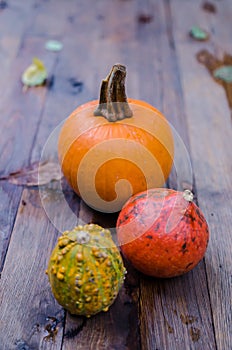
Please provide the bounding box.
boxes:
[58,64,174,212]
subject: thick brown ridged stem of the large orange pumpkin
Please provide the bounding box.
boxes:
[94,64,132,122]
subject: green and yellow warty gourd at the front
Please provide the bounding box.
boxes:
[47,224,126,317]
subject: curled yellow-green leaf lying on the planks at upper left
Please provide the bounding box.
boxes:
[22,57,47,86]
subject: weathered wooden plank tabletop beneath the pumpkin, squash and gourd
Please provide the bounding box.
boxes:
[0,0,232,350]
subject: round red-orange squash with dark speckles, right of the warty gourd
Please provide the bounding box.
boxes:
[117,188,209,277]
